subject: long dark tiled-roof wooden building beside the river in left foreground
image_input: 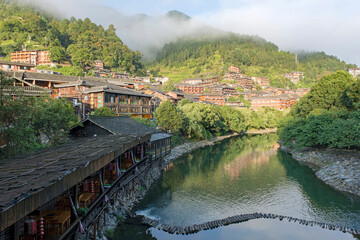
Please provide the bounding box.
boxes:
[0,117,171,240]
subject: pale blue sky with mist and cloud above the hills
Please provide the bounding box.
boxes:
[18,0,360,66]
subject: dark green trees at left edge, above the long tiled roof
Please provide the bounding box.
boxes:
[0,71,78,158]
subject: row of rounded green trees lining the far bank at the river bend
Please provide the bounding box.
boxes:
[155,99,283,140]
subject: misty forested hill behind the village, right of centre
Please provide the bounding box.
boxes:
[153,34,353,87]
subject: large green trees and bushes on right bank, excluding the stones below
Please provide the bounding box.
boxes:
[279,72,360,149]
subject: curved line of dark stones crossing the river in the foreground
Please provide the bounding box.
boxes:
[132,213,360,235]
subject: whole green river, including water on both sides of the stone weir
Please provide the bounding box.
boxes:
[113,134,360,240]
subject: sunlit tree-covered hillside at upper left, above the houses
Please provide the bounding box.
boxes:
[0,0,143,73]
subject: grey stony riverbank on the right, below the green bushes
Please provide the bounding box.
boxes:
[281,146,360,197]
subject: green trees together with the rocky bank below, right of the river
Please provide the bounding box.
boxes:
[278,72,360,196]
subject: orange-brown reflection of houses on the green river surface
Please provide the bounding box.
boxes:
[224,149,278,179]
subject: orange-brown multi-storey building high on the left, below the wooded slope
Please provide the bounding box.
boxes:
[11,50,55,66]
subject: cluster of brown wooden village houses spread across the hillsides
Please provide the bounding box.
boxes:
[0,50,320,118]
